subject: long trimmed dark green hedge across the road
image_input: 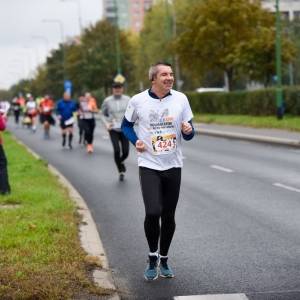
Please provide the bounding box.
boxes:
[185,86,300,116]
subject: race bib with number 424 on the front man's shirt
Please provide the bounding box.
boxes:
[151,133,177,155]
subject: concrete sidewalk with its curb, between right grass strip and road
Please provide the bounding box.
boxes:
[193,123,300,148]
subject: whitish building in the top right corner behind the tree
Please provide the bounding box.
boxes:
[262,0,300,21]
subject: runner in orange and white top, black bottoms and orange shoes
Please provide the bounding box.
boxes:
[79,93,98,153]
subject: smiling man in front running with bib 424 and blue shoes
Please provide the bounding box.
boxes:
[122,62,194,280]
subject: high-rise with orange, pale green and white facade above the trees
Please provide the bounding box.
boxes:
[103,0,155,33]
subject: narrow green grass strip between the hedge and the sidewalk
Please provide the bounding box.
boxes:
[193,113,300,132]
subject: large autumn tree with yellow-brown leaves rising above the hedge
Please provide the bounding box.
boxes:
[174,0,292,90]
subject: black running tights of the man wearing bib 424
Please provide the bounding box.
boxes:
[139,167,181,256]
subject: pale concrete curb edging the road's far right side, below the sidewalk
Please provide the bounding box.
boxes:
[195,128,300,148]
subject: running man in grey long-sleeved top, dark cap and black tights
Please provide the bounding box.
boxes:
[101,82,130,181]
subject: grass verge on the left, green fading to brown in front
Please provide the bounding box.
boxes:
[0,132,109,300]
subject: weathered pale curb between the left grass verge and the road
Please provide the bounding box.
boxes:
[12,136,120,300]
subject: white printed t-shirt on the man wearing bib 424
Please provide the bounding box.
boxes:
[125,90,193,171]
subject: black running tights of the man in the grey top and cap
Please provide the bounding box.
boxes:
[109,130,129,172]
